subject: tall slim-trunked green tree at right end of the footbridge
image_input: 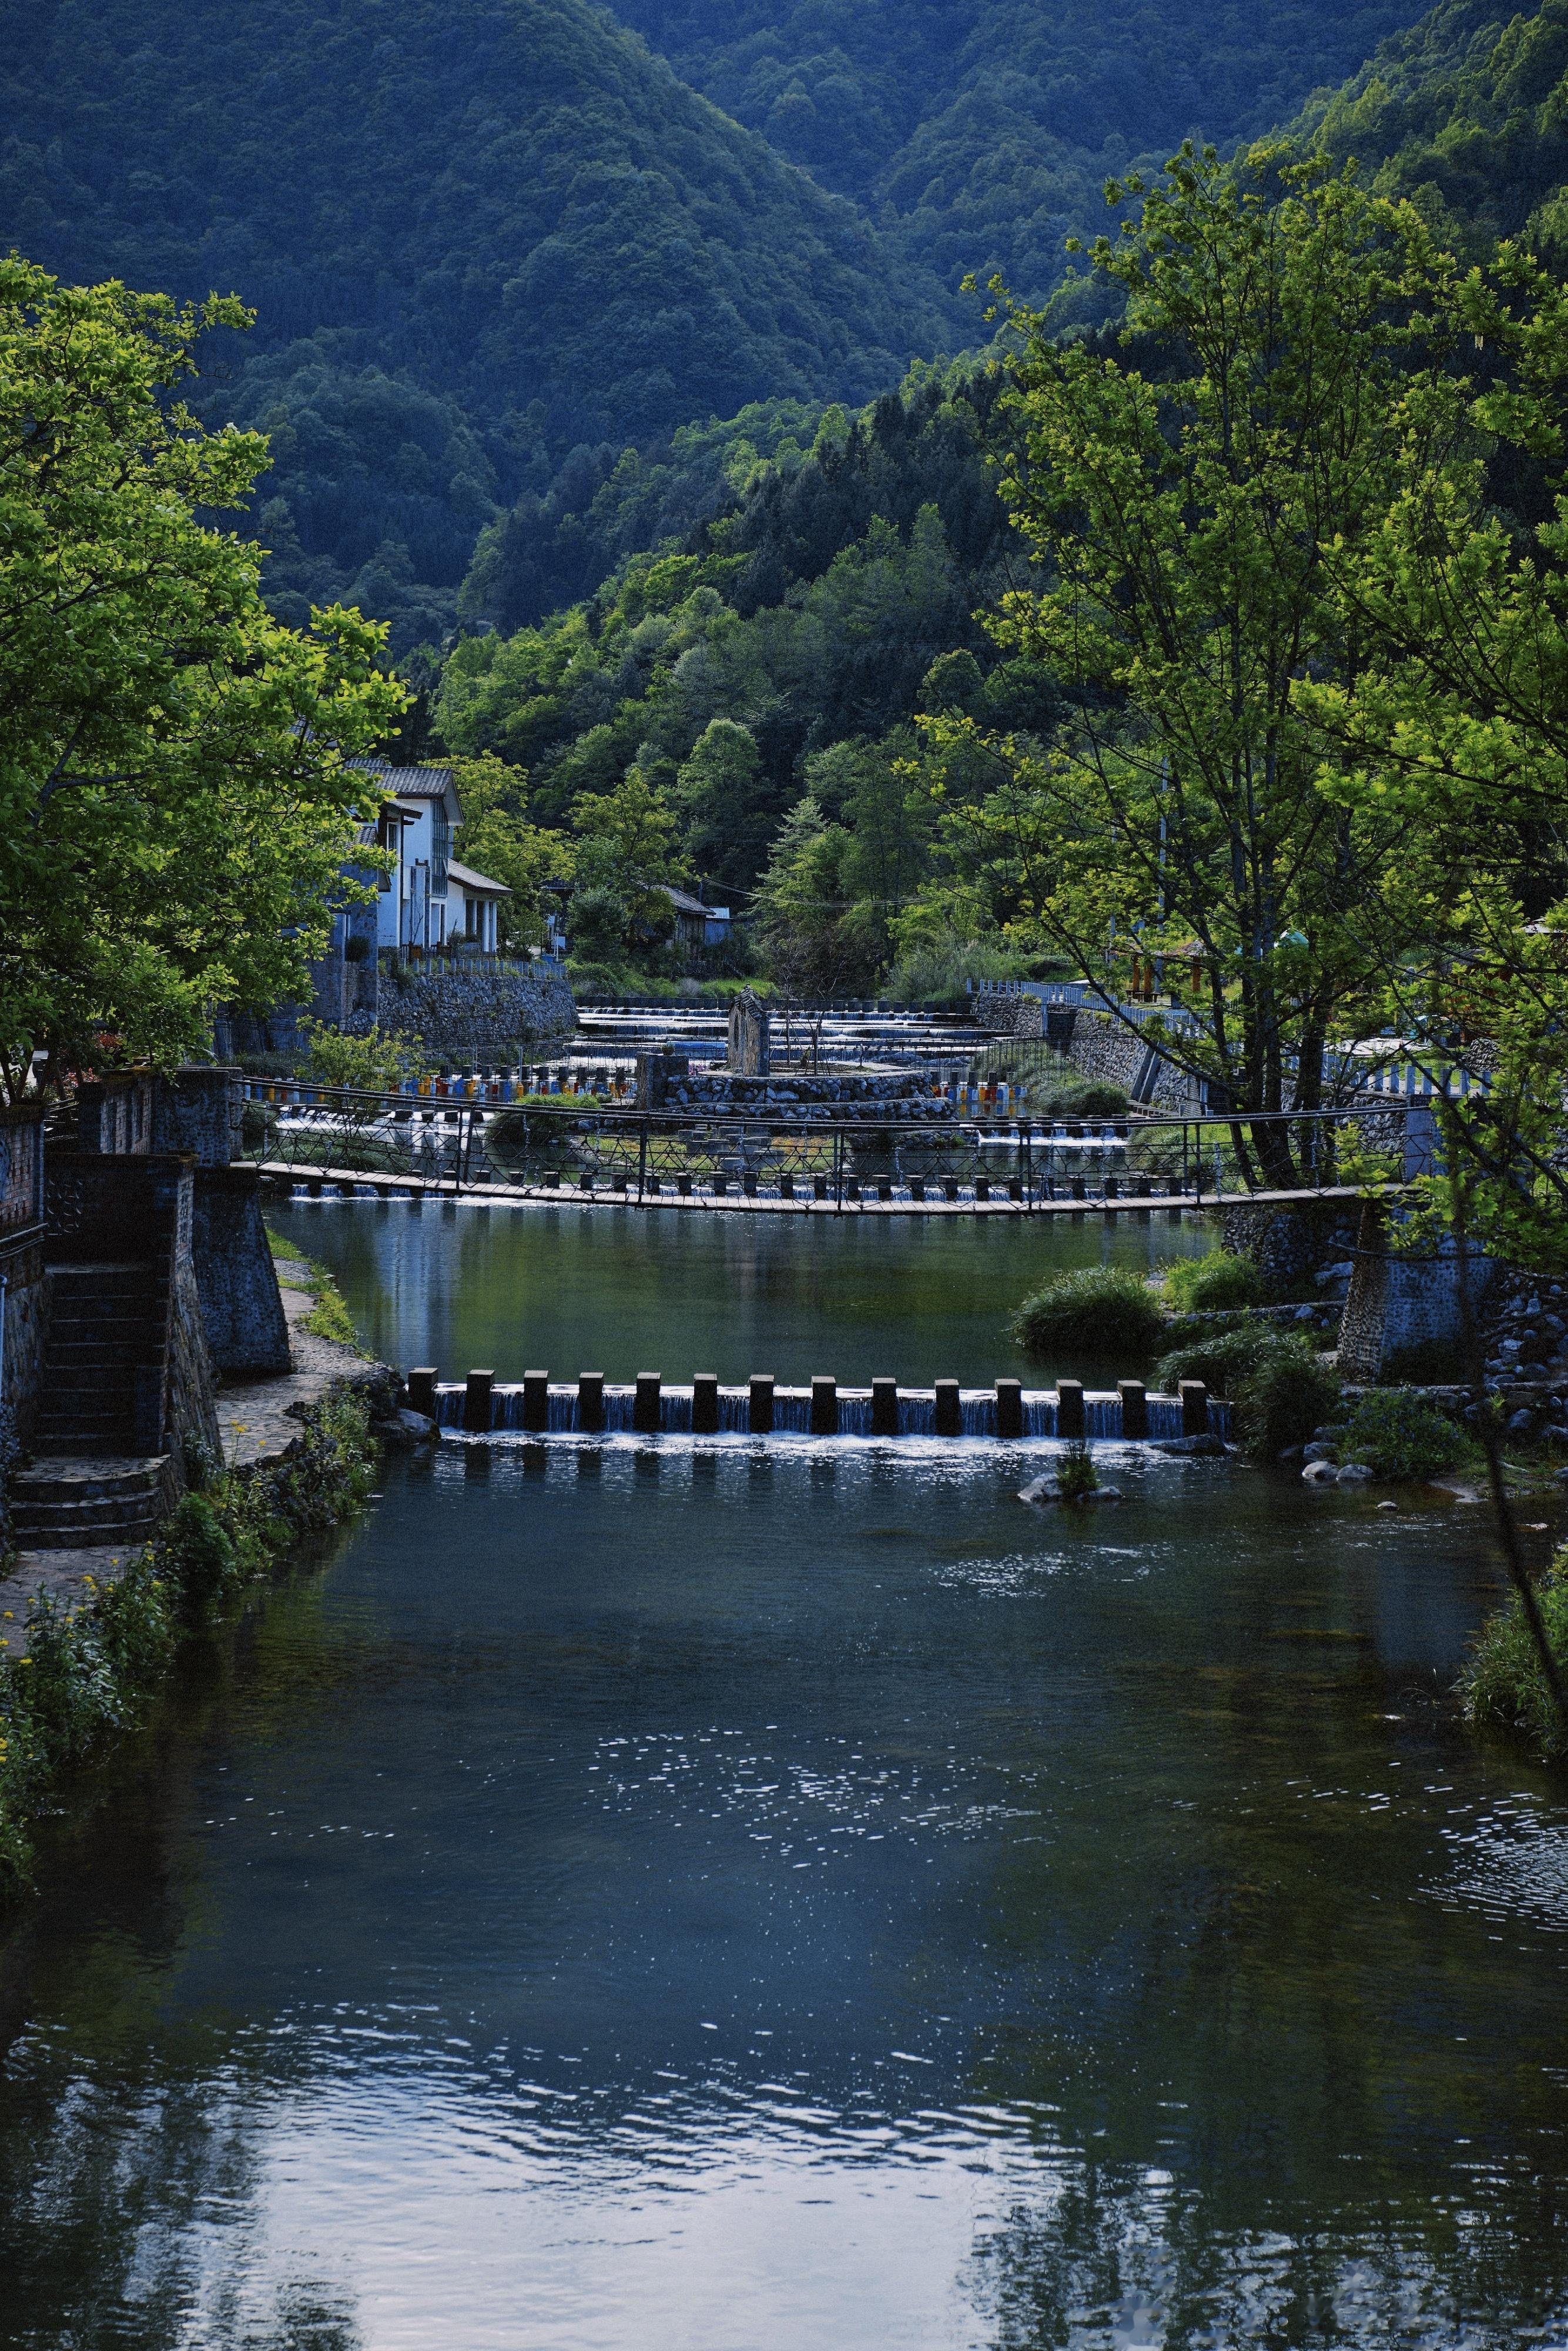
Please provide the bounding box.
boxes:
[931,148,1460,1183]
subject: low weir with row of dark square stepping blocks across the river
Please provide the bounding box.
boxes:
[407,1364,1229,1444]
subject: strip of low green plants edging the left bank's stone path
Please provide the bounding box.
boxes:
[0,1389,376,1909]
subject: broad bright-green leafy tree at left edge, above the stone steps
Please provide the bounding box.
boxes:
[0,256,404,1098]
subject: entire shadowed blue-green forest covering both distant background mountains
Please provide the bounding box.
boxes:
[0,0,1458,654]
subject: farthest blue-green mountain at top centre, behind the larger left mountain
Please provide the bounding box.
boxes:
[614,0,1418,299]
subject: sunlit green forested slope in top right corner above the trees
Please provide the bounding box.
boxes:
[1298,0,1568,263]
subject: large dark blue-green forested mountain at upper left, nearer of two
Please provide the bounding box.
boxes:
[0,0,950,642]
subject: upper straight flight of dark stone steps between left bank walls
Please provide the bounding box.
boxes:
[33,1262,165,1458]
